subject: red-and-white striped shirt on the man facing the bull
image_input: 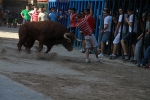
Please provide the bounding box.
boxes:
[76,18,93,36]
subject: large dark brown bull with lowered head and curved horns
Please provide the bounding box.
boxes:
[17,21,80,53]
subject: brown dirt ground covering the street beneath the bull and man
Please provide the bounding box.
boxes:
[0,27,150,100]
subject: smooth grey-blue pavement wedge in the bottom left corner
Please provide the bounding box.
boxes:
[0,74,52,100]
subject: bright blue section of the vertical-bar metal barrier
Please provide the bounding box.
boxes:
[48,0,105,47]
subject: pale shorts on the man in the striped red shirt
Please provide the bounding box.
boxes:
[85,34,98,48]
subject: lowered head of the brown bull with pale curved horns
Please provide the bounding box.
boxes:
[63,33,81,51]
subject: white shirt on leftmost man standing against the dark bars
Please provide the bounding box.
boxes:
[104,15,112,32]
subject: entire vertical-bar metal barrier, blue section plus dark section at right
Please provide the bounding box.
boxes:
[49,0,150,59]
